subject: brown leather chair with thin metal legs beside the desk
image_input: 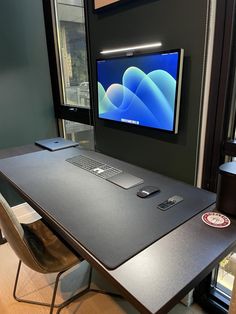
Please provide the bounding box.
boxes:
[0,193,87,313]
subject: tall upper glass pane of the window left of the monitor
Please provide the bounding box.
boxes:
[56,0,90,108]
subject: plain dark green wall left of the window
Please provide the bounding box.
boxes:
[0,0,57,149]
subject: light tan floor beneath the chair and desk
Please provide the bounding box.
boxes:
[0,243,208,314]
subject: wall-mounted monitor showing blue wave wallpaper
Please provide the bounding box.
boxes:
[97,49,184,133]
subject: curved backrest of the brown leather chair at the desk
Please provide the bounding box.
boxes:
[0,193,45,272]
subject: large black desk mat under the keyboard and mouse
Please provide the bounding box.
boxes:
[0,148,215,269]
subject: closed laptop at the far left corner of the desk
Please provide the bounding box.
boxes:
[35,137,79,151]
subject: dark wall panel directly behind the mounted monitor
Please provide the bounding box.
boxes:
[88,0,208,183]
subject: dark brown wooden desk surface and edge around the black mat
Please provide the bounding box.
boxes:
[0,148,236,313]
